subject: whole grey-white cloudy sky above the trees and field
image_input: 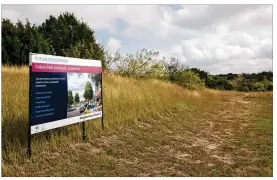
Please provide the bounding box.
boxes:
[2,5,272,74]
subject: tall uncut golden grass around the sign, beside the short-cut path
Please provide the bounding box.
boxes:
[2,66,213,161]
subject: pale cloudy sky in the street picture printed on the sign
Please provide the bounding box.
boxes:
[67,73,95,101]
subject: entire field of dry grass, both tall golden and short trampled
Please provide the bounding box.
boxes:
[2,67,273,176]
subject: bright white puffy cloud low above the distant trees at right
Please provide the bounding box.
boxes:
[164,26,272,74]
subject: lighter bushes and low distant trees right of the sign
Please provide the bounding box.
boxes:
[105,49,273,92]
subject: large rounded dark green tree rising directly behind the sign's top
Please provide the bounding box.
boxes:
[39,12,105,61]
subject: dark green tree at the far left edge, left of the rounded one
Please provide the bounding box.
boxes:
[2,19,50,65]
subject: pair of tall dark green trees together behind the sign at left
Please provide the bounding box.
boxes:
[2,12,105,65]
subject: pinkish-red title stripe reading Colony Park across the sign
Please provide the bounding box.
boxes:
[32,63,102,73]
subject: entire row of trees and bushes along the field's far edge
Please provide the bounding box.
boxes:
[2,12,273,91]
